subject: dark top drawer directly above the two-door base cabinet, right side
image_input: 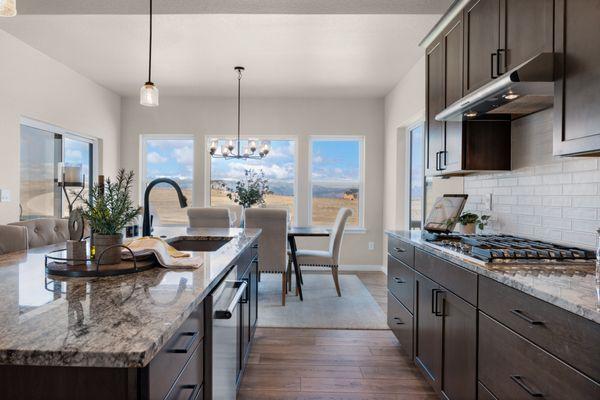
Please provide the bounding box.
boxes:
[415,249,477,305]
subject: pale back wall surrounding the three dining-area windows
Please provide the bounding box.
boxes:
[121,97,384,265]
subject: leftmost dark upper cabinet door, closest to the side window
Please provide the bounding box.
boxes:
[425,40,445,175]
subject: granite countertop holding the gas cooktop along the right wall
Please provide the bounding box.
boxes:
[386,230,600,324]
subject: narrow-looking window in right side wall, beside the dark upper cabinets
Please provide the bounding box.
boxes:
[408,123,425,229]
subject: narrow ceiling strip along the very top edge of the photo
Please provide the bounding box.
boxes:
[17,0,452,15]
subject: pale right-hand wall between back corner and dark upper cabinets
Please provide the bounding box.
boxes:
[383,56,425,229]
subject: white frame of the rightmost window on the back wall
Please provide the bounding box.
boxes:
[307,135,366,232]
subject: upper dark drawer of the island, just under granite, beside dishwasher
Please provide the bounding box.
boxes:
[148,304,204,400]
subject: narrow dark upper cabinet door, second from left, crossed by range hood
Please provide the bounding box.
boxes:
[440,15,463,172]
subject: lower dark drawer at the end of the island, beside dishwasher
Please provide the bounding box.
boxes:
[166,342,204,400]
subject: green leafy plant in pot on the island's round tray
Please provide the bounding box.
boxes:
[82,169,141,264]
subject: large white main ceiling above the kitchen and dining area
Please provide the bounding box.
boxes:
[0,14,439,97]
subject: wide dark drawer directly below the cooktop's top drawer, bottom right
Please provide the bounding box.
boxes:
[478,312,600,400]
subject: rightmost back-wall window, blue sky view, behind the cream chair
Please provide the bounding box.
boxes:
[310,137,364,227]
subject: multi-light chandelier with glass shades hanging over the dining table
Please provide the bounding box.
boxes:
[208,67,270,160]
